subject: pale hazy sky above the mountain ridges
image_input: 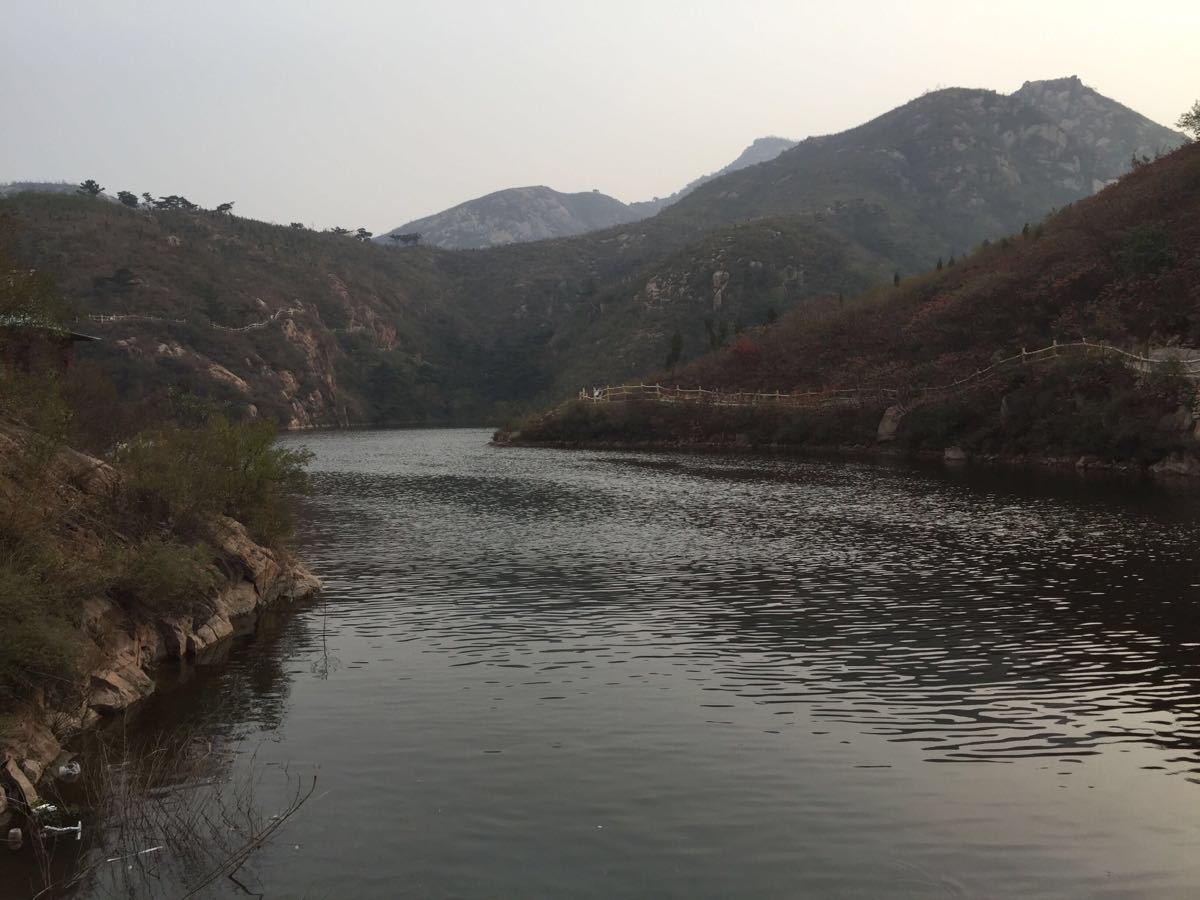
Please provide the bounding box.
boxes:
[0,0,1200,232]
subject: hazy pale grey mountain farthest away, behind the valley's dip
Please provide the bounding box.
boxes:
[377,137,796,250]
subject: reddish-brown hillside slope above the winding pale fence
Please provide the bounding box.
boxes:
[686,144,1200,391]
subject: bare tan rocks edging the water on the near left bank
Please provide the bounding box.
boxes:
[0,518,320,823]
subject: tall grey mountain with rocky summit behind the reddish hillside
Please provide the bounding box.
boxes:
[662,77,1186,252]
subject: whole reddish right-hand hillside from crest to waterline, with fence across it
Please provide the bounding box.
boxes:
[511,144,1200,474]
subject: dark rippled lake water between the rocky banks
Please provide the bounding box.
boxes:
[18,431,1200,898]
